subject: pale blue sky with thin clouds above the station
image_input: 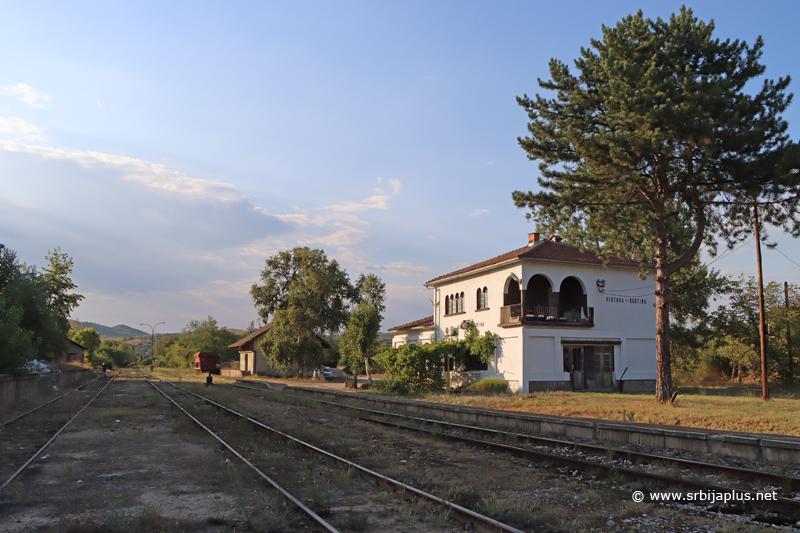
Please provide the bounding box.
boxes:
[0,0,800,333]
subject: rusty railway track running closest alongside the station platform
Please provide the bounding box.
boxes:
[228,378,800,523]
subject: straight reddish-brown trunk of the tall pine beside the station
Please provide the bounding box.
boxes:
[655,222,672,403]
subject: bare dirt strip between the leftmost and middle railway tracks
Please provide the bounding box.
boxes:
[0,379,268,532]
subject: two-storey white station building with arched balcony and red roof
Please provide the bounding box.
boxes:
[389,233,656,392]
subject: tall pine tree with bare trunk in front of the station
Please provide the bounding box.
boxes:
[513,8,800,402]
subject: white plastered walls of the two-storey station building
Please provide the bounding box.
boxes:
[432,261,656,392]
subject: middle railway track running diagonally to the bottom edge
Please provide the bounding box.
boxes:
[143,376,532,533]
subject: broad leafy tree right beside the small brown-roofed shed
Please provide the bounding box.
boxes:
[250,247,358,377]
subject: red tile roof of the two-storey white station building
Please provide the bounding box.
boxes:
[425,240,650,285]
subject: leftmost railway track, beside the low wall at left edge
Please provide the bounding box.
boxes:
[0,372,119,491]
